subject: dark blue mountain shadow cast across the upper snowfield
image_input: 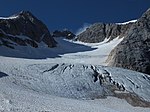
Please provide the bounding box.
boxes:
[0,38,96,59]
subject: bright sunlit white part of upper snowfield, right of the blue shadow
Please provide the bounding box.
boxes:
[61,37,123,65]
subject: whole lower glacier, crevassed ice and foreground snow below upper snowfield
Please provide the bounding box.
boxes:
[0,57,150,112]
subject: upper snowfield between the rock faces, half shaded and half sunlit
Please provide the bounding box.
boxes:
[0,38,123,65]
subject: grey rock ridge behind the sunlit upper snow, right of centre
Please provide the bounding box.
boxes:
[76,23,133,43]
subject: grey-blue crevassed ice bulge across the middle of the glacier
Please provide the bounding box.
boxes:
[1,63,150,101]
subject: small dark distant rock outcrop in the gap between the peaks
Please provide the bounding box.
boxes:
[52,30,76,39]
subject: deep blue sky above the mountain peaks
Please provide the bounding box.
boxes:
[0,0,150,32]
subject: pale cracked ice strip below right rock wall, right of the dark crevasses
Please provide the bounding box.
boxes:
[103,67,150,102]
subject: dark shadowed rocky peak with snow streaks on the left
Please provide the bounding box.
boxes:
[0,11,56,48]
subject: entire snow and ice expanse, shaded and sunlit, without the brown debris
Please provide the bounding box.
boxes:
[0,38,150,112]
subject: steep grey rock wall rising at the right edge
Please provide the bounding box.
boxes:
[107,9,150,75]
